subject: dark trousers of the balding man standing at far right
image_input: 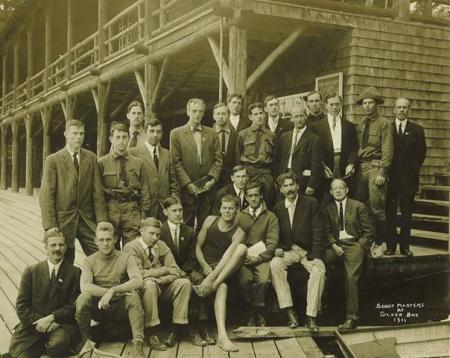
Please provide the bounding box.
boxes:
[386,188,414,251]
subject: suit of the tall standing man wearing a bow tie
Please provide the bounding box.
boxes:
[170,124,223,227]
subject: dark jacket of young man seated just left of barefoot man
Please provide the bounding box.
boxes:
[159,221,197,273]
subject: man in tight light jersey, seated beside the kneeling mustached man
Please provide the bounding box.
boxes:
[75,223,144,358]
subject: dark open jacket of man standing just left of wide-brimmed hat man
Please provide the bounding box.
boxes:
[311,116,359,177]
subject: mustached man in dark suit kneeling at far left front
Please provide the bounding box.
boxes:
[9,231,81,358]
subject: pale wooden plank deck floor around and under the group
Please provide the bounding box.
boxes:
[0,190,445,358]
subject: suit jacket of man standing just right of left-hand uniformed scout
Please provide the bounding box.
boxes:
[128,143,179,217]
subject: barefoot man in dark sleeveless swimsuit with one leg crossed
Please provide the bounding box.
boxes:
[194,195,247,352]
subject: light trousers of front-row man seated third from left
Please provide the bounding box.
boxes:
[142,278,191,327]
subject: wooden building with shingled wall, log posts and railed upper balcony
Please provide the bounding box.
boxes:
[0,0,450,194]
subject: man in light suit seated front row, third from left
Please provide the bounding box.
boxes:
[123,218,191,351]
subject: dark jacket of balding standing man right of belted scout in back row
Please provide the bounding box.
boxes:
[275,128,323,190]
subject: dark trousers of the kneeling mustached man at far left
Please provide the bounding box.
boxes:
[9,324,80,358]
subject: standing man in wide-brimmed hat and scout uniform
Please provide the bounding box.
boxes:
[355,87,394,258]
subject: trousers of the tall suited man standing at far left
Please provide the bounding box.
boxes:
[59,215,98,264]
